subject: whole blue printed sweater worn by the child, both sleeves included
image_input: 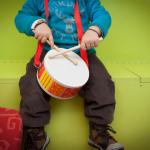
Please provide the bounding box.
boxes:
[15,0,111,52]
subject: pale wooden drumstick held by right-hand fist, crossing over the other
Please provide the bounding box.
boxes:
[49,37,103,58]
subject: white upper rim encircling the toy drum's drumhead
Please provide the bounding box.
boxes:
[43,49,90,89]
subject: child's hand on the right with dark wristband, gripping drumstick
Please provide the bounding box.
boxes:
[81,26,101,49]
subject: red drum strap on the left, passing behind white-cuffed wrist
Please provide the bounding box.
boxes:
[34,0,49,68]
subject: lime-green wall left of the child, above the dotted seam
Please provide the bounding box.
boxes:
[0,0,36,60]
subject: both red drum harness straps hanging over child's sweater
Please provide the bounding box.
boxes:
[34,0,89,68]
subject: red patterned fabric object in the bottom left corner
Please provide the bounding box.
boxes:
[0,107,22,150]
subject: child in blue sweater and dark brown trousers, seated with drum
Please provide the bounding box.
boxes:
[15,0,124,150]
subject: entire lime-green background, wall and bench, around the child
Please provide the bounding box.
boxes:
[0,0,150,150]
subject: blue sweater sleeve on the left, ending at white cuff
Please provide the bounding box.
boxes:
[15,0,44,36]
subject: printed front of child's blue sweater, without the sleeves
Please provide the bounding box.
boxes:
[38,0,89,45]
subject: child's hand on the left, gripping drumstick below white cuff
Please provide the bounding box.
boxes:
[33,23,54,47]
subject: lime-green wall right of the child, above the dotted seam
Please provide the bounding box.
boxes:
[100,0,150,62]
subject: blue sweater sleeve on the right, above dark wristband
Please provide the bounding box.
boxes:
[85,0,111,38]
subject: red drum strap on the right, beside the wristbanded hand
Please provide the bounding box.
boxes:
[74,0,89,65]
